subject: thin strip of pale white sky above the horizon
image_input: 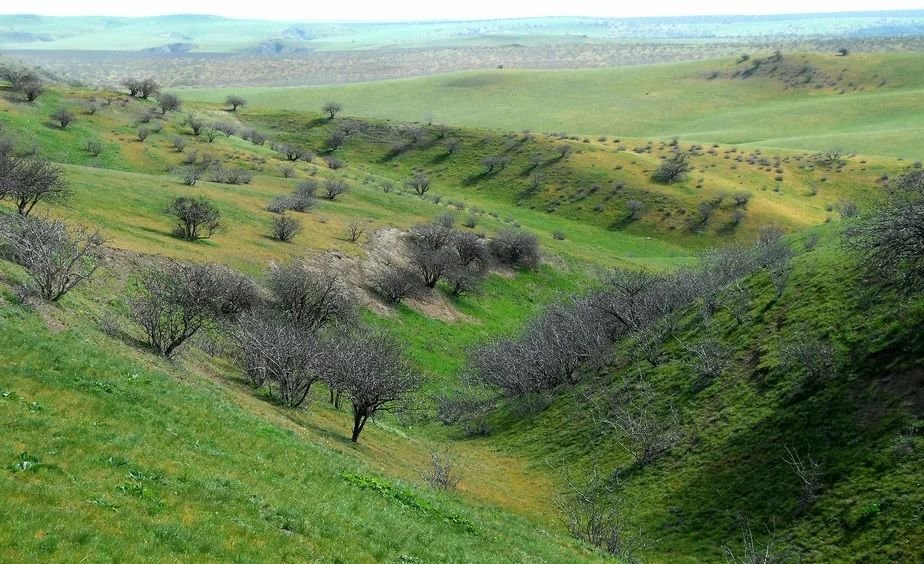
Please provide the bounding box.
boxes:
[0,0,924,20]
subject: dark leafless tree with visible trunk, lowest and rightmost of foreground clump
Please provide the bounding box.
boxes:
[330,330,420,443]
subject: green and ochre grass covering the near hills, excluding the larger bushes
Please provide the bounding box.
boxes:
[0,72,924,562]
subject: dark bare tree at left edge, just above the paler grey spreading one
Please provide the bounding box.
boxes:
[0,149,71,215]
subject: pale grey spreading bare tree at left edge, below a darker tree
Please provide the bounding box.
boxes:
[0,216,104,302]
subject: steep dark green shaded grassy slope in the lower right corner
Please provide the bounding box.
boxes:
[494,229,924,562]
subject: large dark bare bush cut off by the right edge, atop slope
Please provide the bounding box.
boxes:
[845,169,924,293]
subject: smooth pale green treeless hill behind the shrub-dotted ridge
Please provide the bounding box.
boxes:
[186,54,924,158]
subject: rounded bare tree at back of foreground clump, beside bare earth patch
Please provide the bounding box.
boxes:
[268,262,354,333]
